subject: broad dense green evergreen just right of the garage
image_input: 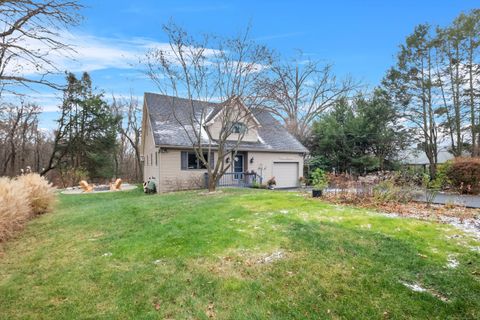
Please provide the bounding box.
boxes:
[311,89,408,173]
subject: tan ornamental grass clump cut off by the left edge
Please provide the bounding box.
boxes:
[0,178,31,242]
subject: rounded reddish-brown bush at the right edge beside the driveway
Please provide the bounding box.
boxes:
[446,158,480,194]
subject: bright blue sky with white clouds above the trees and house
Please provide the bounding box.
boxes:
[32,0,479,127]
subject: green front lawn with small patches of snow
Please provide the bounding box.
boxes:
[0,190,480,319]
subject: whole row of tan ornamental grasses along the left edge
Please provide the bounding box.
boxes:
[0,173,56,242]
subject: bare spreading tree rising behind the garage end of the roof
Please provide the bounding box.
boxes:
[262,54,359,142]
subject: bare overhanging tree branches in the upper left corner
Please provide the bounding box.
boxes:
[0,0,82,91]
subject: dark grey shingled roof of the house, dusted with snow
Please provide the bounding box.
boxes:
[145,92,308,153]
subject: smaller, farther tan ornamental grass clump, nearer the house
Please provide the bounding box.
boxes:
[17,173,56,215]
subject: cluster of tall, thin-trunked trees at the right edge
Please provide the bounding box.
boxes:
[383,9,480,177]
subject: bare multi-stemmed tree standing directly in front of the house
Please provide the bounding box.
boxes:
[145,23,272,191]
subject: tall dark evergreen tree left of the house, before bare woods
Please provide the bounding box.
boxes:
[42,73,119,179]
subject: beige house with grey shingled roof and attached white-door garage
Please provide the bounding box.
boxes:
[141,93,308,192]
